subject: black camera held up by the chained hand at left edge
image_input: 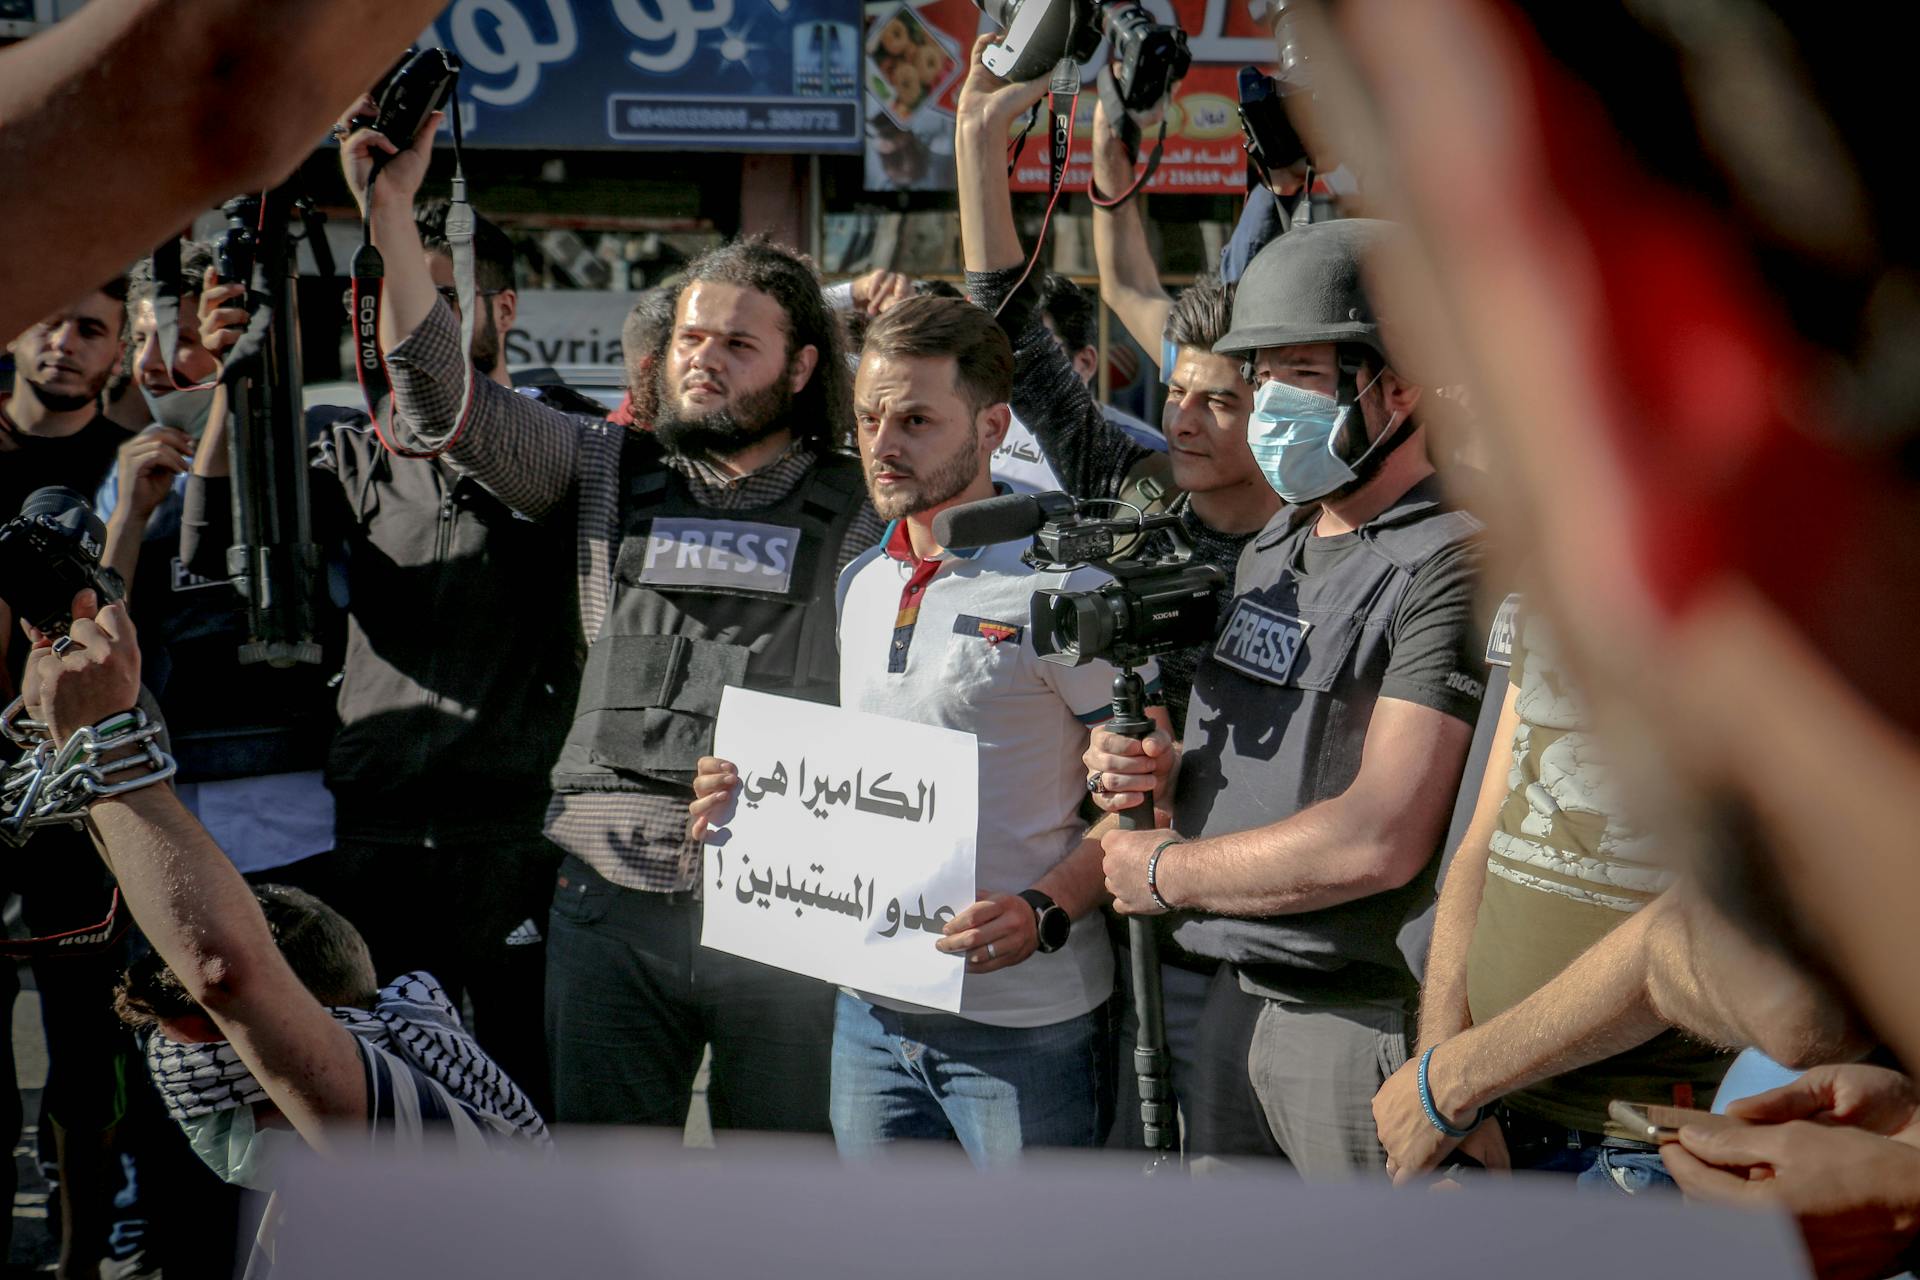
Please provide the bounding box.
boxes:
[0,486,127,635]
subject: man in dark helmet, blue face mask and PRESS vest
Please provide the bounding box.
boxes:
[1087,219,1484,1178]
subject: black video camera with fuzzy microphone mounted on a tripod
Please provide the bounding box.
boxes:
[933,493,1227,668]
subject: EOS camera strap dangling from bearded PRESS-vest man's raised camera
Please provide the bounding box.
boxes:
[351,96,478,459]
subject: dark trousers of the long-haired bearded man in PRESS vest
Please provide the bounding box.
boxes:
[547,856,835,1132]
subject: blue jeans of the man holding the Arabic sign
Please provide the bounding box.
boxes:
[831,992,1114,1167]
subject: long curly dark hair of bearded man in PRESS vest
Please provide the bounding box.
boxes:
[674,236,852,451]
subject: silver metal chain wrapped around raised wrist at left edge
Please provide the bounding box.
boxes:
[0,699,177,844]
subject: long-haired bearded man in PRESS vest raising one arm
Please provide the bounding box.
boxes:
[342,112,883,1130]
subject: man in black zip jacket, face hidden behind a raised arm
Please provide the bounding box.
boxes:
[184,189,580,1105]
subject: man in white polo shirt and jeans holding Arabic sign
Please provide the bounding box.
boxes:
[691,297,1165,1165]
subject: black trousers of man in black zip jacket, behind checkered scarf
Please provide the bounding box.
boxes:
[264,833,561,1115]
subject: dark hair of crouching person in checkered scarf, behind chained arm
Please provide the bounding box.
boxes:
[113,885,378,1027]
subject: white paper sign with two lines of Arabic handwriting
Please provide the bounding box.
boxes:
[701,689,979,1011]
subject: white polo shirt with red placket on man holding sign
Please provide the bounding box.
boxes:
[839,522,1158,1027]
